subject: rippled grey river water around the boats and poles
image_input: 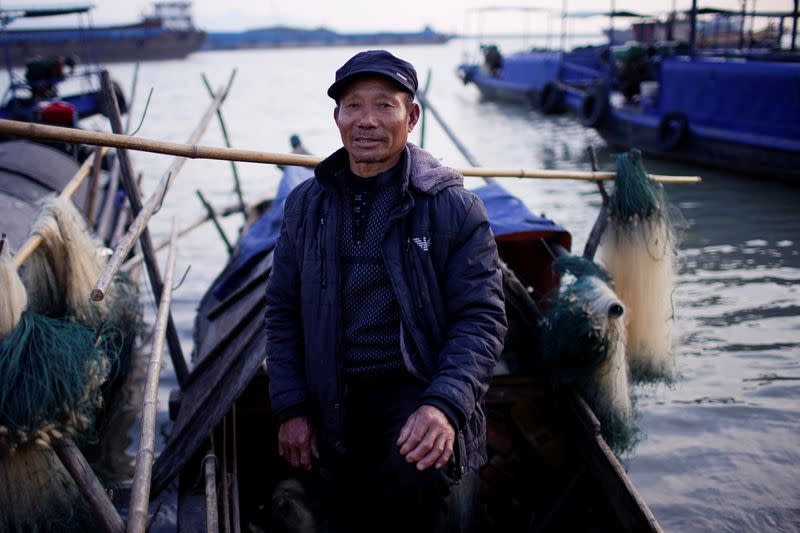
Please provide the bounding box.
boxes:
[32,42,800,532]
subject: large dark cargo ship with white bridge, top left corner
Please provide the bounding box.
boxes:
[0,2,206,66]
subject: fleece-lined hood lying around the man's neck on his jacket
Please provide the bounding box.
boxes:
[314,143,464,194]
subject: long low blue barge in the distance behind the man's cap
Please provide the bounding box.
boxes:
[203,26,451,50]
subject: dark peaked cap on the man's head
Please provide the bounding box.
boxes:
[328,50,417,100]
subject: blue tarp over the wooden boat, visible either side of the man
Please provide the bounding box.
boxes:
[209,167,567,299]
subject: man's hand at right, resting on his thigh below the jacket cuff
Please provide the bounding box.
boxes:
[397,405,456,470]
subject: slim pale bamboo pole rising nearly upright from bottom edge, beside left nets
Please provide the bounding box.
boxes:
[126,217,178,533]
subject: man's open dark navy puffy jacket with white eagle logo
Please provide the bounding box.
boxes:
[266,144,506,473]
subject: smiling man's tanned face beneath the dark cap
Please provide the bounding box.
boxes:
[333,76,420,177]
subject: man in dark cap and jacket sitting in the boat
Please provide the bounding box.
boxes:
[266,50,506,531]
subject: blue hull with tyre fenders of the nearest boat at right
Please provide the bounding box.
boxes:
[578,57,800,181]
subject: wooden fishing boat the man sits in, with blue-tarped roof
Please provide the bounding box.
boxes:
[151,167,660,531]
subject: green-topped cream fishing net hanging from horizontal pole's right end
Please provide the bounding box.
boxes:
[598,150,676,382]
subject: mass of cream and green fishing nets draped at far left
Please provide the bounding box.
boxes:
[0,194,141,533]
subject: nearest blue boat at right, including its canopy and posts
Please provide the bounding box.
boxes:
[577,8,800,183]
